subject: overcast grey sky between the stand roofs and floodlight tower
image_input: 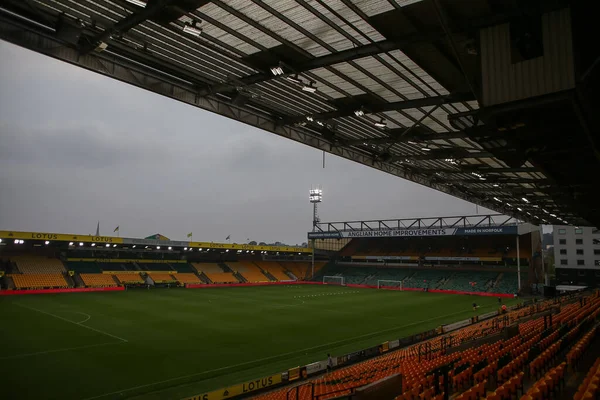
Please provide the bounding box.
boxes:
[0,41,496,244]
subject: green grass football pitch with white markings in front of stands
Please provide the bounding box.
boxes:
[0,285,516,400]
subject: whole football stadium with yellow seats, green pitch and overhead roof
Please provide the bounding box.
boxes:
[0,0,600,400]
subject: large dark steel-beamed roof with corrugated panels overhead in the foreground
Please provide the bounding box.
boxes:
[0,0,600,225]
